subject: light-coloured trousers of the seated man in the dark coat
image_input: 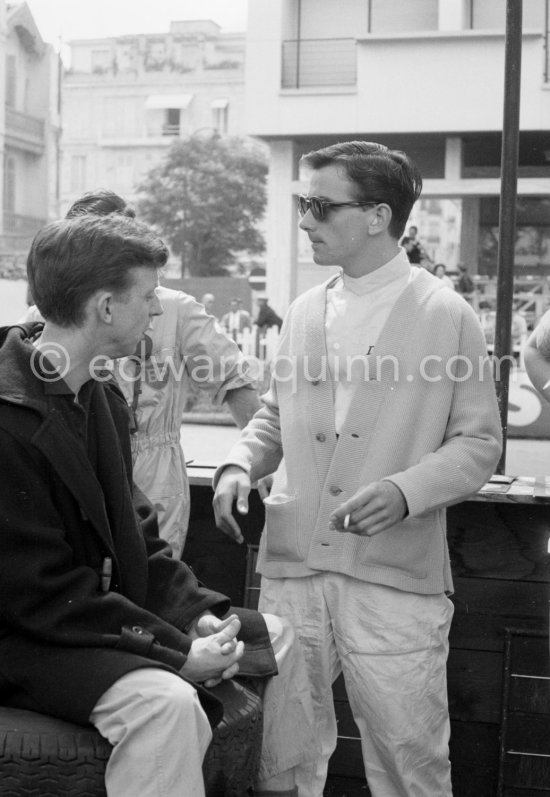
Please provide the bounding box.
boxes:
[90,614,318,797]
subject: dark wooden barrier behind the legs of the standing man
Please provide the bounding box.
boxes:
[188,482,550,797]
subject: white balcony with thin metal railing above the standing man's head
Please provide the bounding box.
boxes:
[246,30,550,140]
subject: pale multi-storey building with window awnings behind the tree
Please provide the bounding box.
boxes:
[62,20,245,215]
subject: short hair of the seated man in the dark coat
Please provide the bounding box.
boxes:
[27,213,168,327]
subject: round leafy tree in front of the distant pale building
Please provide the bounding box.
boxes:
[138,134,267,277]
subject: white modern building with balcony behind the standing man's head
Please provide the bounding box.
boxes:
[246,0,550,312]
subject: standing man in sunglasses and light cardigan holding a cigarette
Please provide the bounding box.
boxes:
[214,141,500,797]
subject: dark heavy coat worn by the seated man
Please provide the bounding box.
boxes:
[0,325,276,723]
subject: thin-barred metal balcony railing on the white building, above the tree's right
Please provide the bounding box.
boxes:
[281,39,357,89]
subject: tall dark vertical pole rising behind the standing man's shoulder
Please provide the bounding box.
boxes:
[494,0,522,473]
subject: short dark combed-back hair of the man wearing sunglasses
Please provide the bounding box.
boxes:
[301,141,422,239]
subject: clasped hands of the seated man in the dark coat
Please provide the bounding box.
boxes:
[180,615,244,687]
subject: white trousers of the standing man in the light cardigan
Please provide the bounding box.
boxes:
[260,573,453,797]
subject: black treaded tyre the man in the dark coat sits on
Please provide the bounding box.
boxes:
[0,682,262,797]
